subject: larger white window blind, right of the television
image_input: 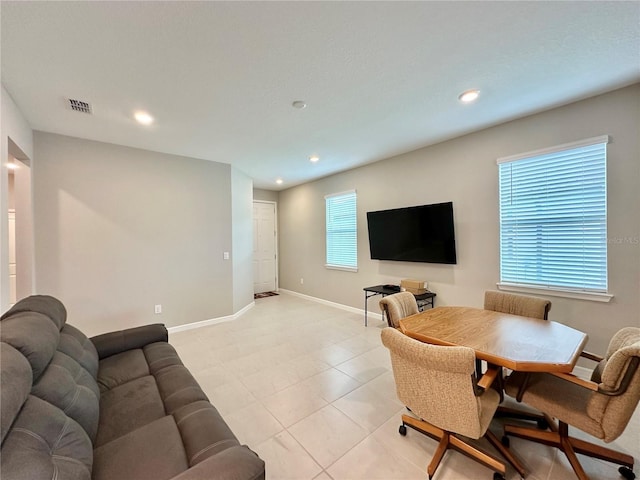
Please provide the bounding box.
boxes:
[498,136,608,292]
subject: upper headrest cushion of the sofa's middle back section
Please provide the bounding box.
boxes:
[0,312,60,380]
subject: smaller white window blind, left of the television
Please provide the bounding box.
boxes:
[325,191,358,270]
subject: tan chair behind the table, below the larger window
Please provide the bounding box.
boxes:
[484,290,551,429]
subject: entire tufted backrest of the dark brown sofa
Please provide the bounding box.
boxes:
[0,295,100,479]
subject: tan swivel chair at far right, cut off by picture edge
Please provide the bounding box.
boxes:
[503,327,640,480]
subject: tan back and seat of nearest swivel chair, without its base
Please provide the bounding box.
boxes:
[382,327,500,438]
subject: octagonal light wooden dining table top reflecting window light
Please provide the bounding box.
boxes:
[400,307,588,374]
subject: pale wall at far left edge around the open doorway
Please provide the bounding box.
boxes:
[0,85,33,312]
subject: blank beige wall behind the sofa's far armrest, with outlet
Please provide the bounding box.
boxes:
[33,132,238,335]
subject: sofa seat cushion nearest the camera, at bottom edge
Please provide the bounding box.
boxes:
[93,416,189,480]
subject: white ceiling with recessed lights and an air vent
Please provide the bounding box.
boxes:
[0,0,640,190]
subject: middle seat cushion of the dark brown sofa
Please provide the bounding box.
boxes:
[95,375,166,447]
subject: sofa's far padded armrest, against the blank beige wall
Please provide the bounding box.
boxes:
[90,323,169,360]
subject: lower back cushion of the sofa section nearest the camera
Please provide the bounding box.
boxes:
[2,395,93,480]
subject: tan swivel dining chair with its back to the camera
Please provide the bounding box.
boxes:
[381,327,525,480]
